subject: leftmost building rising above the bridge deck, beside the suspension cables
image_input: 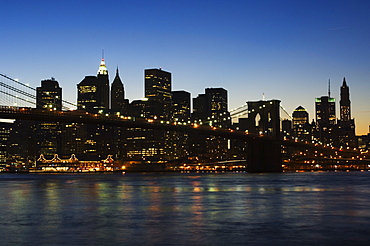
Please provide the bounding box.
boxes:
[36,78,62,111]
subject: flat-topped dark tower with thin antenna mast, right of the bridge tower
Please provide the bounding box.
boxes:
[315,82,339,146]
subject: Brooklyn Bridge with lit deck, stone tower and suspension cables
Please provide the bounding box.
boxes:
[0,74,369,172]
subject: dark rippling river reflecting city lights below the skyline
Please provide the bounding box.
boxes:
[0,172,370,245]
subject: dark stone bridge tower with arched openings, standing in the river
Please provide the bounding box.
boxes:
[246,100,282,172]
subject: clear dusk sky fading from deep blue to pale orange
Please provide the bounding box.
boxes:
[0,0,370,135]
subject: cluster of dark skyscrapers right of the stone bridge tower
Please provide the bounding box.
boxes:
[282,78,358,148]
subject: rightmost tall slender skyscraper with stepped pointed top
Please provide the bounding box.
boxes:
[338,78,358,147]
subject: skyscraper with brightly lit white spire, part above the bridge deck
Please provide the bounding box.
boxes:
[77,58,109,113]
